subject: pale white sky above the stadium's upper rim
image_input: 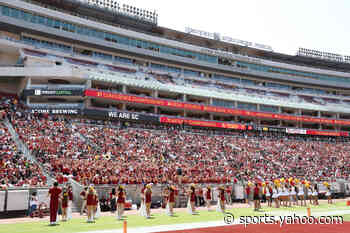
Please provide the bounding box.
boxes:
[119,0,350,55]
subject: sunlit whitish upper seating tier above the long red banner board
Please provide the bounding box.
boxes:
[87,70,350,113]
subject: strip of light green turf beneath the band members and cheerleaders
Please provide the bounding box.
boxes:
[0,202,350,233]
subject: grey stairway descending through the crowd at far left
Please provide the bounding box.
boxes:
[3,119,54,185]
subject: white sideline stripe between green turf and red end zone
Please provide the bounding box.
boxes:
[78,210,350,233]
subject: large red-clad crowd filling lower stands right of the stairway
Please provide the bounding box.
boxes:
[8,108,350,187]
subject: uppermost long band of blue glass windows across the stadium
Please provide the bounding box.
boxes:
[0,16,350,90]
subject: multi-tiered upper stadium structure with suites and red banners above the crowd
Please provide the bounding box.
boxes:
[0,0,350,136]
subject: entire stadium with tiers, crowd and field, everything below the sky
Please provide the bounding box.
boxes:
[0,0,350,233]
